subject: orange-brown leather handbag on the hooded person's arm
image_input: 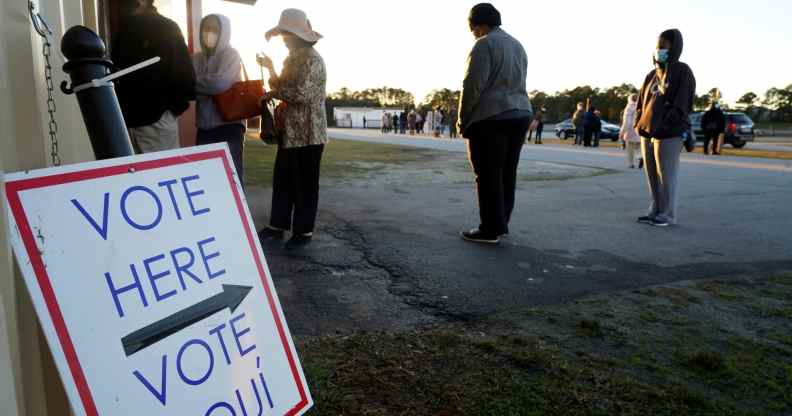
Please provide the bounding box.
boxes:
[214,64,264,122]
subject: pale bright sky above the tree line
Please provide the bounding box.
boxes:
[193,0,792,102]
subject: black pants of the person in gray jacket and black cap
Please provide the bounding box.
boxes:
[466,118,531,236]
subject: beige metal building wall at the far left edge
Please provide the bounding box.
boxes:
[0,0,96,416]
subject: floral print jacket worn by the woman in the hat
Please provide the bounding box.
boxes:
[270,47,327,149]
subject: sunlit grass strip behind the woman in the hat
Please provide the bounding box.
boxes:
[245,139,438,187]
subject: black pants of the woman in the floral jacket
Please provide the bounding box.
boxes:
[270,144,324,234]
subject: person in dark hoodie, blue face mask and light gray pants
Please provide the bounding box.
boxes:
[635,29,696,227]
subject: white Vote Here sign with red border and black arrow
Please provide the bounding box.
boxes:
[5,144,313,416]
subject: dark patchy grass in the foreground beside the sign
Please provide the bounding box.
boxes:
[296,275,792,416]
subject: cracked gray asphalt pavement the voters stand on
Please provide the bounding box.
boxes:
[248,132,792,336]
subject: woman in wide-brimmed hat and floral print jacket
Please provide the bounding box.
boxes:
[258,9,327,249]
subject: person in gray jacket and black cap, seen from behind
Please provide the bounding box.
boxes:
[458,3,533,244]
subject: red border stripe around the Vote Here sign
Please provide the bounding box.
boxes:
[5,150,308,416]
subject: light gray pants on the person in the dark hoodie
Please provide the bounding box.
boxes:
[641,137,683,224]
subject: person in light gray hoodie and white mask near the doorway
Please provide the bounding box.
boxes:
[193,14,245,183]
